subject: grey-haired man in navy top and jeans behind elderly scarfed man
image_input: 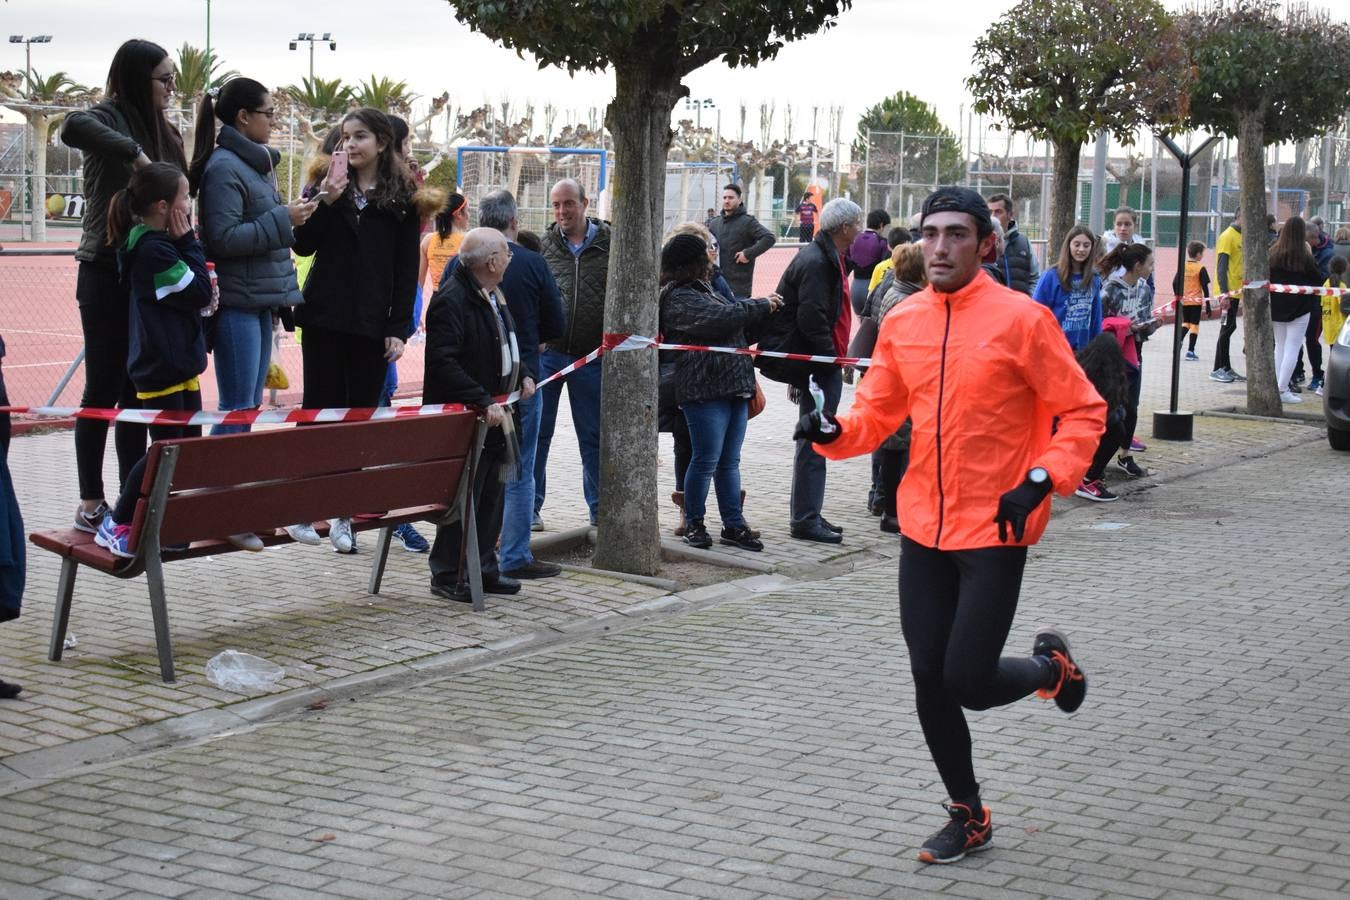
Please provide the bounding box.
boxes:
[475,190,567,579]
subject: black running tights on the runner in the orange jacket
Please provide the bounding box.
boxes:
[900,537,1052,800]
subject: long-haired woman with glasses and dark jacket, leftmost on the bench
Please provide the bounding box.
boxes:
[61,39,188,533]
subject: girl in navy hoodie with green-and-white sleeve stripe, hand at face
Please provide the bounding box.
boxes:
[95,162,213,559]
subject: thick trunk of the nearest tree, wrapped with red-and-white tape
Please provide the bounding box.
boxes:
[595,58,680,575]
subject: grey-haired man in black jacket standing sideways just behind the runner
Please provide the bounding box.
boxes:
[759,198,863,544]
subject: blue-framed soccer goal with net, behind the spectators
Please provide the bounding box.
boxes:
[455,147,609,235]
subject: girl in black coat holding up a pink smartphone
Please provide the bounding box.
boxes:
[294,108,440,553]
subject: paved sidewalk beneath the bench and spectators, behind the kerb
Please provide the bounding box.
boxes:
[0,315,1316,765]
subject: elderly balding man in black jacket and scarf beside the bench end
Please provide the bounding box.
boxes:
[423,228,535,603]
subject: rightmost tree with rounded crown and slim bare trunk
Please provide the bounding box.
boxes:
[1177,0,1350,416]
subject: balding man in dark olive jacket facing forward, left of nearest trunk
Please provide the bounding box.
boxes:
[535,178,609,528]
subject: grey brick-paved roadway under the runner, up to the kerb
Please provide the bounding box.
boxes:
[0,434,1350,900]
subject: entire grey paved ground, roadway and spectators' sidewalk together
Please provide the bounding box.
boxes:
[0,319,1350,897]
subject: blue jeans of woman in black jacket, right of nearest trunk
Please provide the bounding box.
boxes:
[680,397,749,528]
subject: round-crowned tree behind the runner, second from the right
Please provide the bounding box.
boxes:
[965,0,1187,256]
